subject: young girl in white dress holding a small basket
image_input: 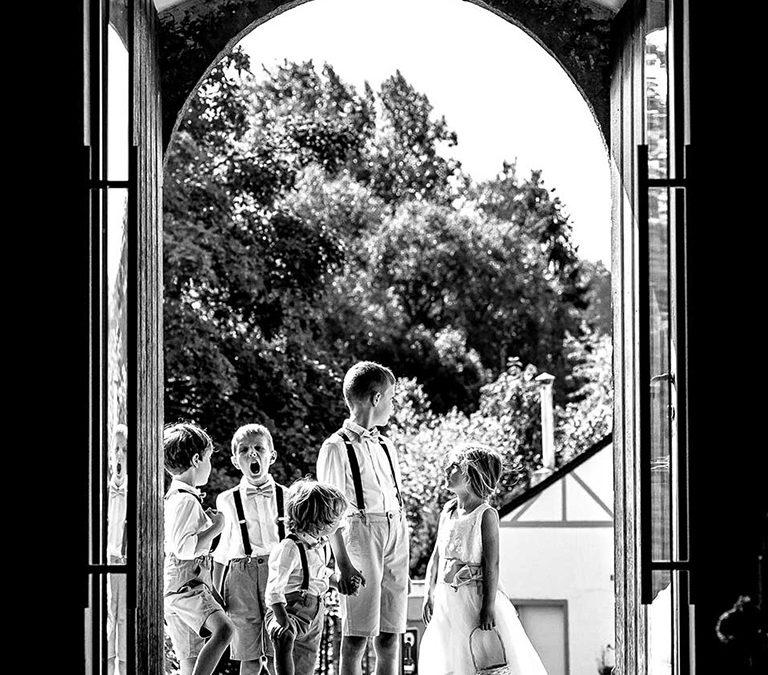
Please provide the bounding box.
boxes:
[419,445,546,675]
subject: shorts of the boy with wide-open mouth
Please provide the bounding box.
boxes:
[221,555,273,661]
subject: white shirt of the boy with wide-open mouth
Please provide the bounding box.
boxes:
[213,475,279,565]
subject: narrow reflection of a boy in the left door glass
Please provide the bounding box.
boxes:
[107,424,128,675]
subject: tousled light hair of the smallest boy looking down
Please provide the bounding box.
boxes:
[285,478,347,535]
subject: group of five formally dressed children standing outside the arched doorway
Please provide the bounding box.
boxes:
[163,361,544,675]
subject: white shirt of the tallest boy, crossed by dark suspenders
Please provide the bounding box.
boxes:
[317,419,402,515]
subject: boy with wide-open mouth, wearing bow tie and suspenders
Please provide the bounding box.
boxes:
[213,424,285,675]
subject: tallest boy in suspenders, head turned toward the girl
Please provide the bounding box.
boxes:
[317,361,408,675]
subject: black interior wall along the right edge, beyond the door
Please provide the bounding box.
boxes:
[688,7,768,673]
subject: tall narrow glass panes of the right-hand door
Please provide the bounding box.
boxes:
[640,0,679,675]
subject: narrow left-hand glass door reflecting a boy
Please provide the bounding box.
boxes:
[85,0,134,675]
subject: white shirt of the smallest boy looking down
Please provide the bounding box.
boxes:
[264,534,333,605]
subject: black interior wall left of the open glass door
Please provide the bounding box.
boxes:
[29,3,90,672]
